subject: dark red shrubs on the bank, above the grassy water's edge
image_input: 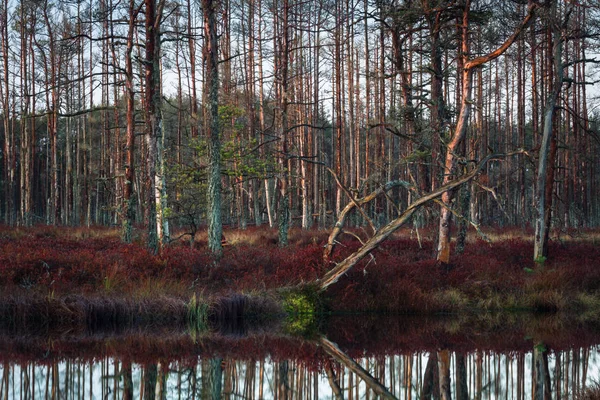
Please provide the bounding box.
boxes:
[0,227,600,312]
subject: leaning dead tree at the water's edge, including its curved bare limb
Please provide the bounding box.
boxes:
[317,150,528,291]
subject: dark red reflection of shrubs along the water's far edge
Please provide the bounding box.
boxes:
[0,314,598,368]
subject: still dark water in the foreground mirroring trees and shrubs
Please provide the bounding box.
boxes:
[0,316,600,400]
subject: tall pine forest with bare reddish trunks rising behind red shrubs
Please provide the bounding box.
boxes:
[0,0,600,255]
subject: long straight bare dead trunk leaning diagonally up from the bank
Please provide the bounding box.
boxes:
[316,150,527,292]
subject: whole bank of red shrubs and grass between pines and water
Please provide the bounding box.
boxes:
[0,226,600,327]
